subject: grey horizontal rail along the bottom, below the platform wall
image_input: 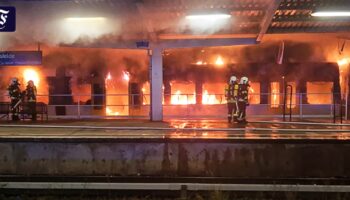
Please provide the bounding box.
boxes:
[0,182,350,192]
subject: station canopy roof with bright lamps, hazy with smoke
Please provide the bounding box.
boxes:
[0,0,350,46]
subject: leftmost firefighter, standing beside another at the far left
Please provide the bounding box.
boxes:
[7,78,22,121]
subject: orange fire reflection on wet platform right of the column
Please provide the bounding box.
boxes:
[166,120,350,140]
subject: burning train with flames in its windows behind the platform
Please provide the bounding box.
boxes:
[0,41,348,117]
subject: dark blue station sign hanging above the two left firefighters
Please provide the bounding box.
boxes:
[0,51,42,66]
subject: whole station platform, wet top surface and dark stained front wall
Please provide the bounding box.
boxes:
[0,119,350,179]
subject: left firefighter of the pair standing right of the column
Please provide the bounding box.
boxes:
[225,76,238,123]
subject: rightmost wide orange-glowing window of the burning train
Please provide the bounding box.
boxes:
[306,82,333,104]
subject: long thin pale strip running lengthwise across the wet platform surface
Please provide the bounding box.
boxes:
[0,125,350,133]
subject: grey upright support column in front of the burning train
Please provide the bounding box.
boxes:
[150,47,163,121]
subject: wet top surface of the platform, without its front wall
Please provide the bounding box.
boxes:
[0,119,350,142]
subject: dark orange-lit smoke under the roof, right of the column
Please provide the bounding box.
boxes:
[164,40,327,82]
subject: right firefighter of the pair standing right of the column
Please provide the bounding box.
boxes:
[237,77,250,123]
